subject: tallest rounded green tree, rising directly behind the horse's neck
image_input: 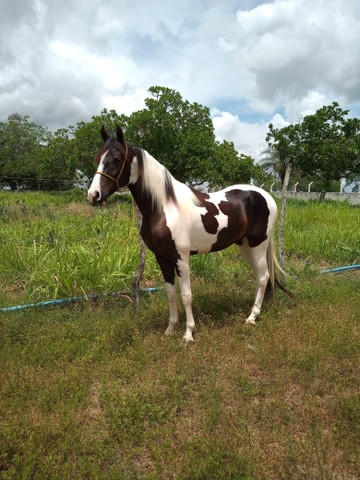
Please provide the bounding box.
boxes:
[126,86,215,184]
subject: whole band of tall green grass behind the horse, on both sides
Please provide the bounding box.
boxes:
[0,191,360,299]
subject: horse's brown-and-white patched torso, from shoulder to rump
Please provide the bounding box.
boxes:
[166,185,276,253]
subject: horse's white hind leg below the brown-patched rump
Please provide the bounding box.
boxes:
[240,240,270,325]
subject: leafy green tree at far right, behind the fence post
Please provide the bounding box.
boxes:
[266,102,360,191]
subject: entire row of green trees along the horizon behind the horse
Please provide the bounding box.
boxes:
[0,86,360,190]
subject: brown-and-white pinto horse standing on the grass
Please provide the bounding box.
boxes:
[88,126,281,342]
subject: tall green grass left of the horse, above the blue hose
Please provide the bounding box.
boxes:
[0,189,160,298]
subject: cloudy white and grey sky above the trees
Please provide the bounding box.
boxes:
[0,0,360,158]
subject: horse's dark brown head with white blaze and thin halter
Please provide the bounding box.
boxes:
[88,126,130,205]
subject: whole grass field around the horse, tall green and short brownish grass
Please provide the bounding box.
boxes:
[0,192,360,480]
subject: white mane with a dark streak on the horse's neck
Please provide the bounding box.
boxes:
[135,148,199,210]
